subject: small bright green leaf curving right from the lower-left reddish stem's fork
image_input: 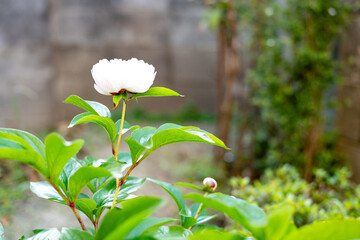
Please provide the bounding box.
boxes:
[68,166,111,201]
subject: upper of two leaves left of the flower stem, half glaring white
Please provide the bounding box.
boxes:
[64,95,111,118]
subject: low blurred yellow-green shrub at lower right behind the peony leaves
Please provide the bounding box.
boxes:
[231,165,360,226]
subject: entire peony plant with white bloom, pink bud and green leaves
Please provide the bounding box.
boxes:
[0,58,360,240]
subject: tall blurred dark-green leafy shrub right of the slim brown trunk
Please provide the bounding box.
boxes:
[242,0,349,171]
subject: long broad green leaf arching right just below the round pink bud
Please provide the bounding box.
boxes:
[184,193,267,238]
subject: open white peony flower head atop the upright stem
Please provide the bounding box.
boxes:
[91,58,156,95]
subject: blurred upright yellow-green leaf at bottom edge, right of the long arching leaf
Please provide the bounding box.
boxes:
[265,204,296,240]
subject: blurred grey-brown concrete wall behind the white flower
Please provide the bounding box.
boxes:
[0,0,216,130]
